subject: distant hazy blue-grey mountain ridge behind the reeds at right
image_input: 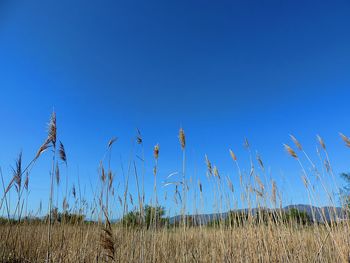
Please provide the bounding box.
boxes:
[169,204,348,224]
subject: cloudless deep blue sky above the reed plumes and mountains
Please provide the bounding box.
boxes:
[0,0,350,218]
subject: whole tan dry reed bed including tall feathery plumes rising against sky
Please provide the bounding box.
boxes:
[0,113,350,262]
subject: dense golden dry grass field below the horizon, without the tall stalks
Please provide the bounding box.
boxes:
[0,225,350,262]
